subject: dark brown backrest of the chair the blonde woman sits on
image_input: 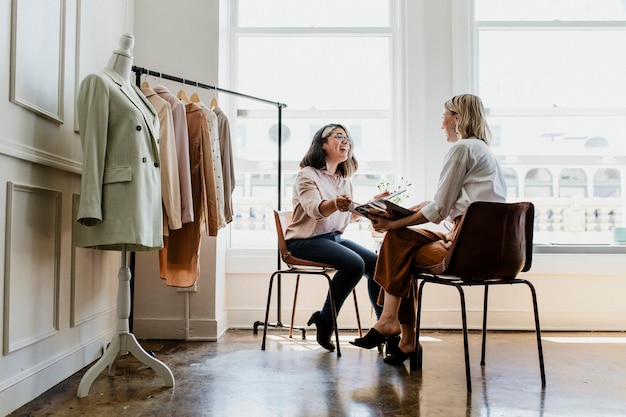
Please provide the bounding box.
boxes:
[444,202,535,281]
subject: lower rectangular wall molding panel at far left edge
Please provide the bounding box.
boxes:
[3,181,62,355]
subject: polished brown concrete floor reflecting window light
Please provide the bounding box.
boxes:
[10,330,626,417]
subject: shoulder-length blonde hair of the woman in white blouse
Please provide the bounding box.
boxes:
[444,94,491,145]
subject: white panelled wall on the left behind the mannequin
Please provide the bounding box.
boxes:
[0,0,132,415]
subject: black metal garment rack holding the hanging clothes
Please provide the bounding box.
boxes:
[130,65,294,337]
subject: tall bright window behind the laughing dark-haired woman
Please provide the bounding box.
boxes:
[228,0,401,248]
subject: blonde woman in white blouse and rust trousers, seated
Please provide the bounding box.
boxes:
[350,94,506,366]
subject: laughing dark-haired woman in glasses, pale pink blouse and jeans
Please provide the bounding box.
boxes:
[285,124,384,352]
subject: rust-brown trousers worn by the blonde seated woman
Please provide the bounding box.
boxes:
[374,222,458,325]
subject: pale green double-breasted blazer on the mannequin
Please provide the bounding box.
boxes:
[74,69,163,251]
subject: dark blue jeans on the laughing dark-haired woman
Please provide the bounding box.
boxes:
[287,232,382,322]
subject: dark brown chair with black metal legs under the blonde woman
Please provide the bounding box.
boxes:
[411,202,546,392]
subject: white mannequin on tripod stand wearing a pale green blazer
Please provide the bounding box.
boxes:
[74,33,174,397]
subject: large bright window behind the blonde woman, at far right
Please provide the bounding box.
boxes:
[474,0,626,244]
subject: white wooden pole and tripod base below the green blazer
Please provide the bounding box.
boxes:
[78,249,174,398]
